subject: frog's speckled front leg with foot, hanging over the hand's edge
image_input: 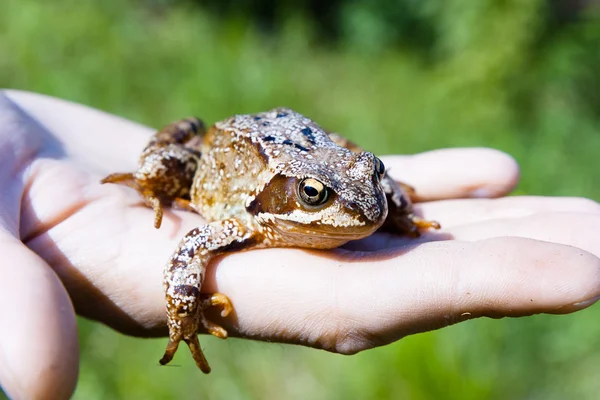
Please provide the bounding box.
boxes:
[160,218,258,373]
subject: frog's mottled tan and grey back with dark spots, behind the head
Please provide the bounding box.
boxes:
[191,108,358,221]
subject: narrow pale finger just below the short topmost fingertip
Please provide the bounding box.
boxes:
[416,196,600,229]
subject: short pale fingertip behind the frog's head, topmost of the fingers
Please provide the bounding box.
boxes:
[382,148,519,201]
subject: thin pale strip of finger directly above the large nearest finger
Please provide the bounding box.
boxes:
[448,212,600,256]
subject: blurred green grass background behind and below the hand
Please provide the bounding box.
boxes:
[0,0,600,399]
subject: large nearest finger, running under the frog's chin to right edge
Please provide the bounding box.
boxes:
[199,238,600,353]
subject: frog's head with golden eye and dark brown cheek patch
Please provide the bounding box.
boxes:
[247,146,388,248]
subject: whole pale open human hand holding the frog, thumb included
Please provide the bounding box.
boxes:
[0,91,600,399]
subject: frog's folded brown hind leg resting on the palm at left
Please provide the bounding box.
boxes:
[101,118,205,228]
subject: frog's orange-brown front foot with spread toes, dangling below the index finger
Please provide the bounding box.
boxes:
[159,293,233,374]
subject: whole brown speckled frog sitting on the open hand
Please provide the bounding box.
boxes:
[101,107,440,373]
